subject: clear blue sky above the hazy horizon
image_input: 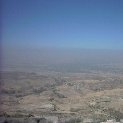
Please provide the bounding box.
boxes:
[1,0,123,50]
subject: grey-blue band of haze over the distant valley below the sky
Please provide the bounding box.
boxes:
[2,48,123,72]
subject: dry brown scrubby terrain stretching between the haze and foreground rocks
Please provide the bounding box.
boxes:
[0,64,123,122]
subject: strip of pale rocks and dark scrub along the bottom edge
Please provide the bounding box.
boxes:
[0,116,123,123]
